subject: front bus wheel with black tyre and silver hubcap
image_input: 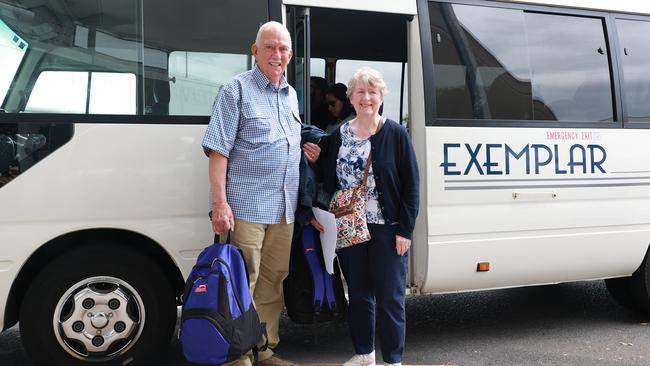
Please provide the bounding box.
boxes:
[20,245,176,365]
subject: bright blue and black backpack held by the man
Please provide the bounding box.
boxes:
[180,243,266,365]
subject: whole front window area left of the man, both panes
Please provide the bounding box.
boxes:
[0,0,268,115]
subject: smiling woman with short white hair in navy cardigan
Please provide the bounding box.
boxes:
[312,67,419,366]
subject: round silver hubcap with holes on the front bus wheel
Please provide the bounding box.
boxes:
[53,277,145,362]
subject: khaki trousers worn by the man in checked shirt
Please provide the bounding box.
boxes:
[226,219,293,366]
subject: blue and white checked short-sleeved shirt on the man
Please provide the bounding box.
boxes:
[203,67,302,224]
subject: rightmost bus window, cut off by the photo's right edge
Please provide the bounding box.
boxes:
[616,19,650,121]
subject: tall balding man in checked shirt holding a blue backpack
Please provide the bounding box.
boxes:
[202,22,320,366]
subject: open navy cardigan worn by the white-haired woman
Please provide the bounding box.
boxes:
[318,119,420,239]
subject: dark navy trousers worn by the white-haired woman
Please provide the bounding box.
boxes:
[338,224,408,363]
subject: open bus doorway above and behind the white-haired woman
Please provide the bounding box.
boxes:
[286,3,413,274]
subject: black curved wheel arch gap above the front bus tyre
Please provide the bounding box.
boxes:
[3,228,184,330]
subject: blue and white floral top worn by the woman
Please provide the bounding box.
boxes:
[336,119,385,224]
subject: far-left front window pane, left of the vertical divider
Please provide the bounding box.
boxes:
[0,0,140,114]
